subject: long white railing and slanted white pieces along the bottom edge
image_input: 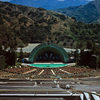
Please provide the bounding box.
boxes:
[0,92,100,100]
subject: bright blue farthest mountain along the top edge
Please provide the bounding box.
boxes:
[10,0,89,10]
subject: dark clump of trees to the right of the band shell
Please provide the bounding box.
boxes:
[74,40,100,69]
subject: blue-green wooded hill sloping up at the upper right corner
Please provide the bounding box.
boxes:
[55,0,100,23]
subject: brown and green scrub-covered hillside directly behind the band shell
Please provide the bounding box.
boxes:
[0,2,100,49]
